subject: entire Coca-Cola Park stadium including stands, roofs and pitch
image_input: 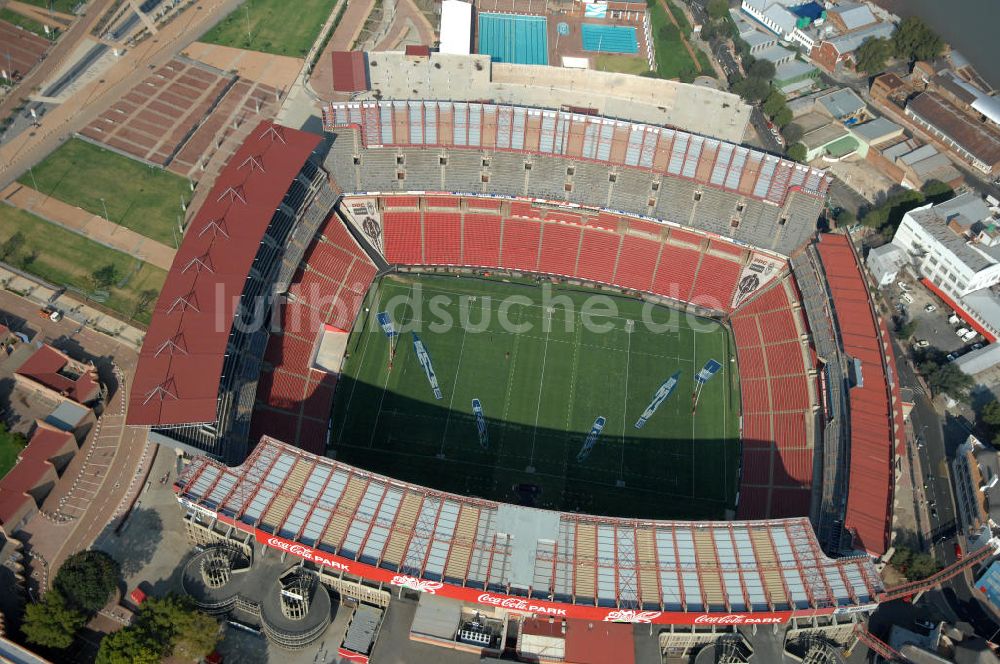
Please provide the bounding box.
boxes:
[128,76,928,650]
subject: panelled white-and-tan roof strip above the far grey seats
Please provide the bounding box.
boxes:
[323,101,829,205]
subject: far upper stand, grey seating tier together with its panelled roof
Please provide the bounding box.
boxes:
[323,101,829,255]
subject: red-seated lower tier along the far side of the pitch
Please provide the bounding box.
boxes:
[364,195,748,312]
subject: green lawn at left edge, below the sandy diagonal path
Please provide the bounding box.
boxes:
[0,204,167,323]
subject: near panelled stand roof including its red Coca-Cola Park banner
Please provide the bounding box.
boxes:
[175,437,888,624]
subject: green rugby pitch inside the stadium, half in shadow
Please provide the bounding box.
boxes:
[330,274,739,519]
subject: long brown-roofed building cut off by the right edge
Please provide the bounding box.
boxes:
[906,91,1000,176]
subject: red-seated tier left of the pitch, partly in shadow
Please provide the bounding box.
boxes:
[250,214,376,454]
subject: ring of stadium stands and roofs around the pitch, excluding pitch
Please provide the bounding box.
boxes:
[128,84,902,644]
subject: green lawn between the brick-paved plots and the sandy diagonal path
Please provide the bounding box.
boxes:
[18,138,191,247]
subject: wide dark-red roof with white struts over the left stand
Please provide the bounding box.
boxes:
[128,121,320,426]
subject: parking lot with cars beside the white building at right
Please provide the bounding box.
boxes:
[882,273,983,355]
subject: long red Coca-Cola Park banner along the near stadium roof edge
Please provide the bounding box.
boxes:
[250,524,834,625]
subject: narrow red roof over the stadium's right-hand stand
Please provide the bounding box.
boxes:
[819,235,896,556]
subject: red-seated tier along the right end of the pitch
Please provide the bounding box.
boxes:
[731,275,818,519]
